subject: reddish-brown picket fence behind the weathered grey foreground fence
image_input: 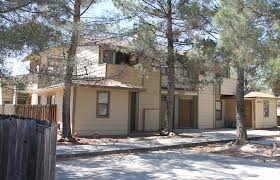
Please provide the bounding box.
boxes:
[0,105,56,122]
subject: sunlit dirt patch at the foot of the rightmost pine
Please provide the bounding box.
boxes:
[190,139,280,163]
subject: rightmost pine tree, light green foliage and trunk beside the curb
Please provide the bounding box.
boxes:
[214,0,278,144]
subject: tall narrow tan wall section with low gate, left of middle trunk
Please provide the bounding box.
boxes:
[137,71,160,131]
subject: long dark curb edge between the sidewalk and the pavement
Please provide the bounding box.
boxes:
[56,135,280,161]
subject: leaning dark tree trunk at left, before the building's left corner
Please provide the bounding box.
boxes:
[62,0,81,140]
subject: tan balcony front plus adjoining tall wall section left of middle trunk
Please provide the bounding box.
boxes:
[106,64,160,131]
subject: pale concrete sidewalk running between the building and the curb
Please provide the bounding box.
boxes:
[56,129,280,160]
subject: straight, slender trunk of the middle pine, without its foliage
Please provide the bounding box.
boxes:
[166,0,175,132]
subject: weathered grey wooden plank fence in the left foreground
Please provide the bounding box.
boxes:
[0,115,57,180]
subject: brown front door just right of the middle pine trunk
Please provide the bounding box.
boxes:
[178,99,193,128]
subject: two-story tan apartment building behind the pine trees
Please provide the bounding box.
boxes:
[25,41,254,136]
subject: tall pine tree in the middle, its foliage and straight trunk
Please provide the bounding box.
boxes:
[114,0,213,132]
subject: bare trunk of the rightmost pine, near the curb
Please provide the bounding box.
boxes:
[235,67,247,145]
